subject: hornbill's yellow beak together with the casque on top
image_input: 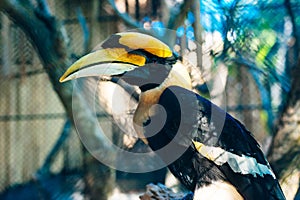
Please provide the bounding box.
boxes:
[59,32,172,82]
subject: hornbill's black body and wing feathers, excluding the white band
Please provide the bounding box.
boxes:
[145,86,285,199]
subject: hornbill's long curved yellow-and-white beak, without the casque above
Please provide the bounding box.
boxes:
[59,48,146,82]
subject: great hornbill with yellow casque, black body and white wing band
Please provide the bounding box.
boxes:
[60,32,285,199]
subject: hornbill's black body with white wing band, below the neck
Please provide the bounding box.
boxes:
[145,86,284,199]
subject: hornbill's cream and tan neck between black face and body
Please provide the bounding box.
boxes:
[133,62,192,144]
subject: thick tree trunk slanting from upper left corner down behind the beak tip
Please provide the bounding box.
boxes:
[0,0,116,199]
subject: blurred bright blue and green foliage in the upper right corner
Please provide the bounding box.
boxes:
[201,0,300,128]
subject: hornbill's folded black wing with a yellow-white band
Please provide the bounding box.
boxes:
[154,86,284,199]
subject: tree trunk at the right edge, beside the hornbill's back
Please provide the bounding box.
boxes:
[268,59,300,199]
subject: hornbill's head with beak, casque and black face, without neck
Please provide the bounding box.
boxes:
[60,32,190,92]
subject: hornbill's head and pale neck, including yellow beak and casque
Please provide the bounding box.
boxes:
[60,32,191,143]
